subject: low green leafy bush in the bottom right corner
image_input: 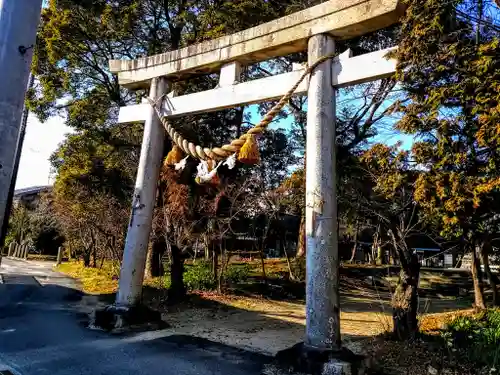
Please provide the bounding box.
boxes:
[442,309,500,368]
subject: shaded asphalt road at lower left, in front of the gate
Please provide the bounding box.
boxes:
[0,258,270,375]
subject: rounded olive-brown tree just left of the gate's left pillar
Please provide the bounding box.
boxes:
[52,128,137,267]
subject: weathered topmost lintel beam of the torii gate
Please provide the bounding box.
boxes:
[109,0,403,88]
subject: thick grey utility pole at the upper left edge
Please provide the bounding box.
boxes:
[0,0,42,244]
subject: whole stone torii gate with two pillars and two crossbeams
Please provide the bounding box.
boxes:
[109,0,403,356]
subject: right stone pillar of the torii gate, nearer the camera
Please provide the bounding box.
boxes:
[305,34,341,350]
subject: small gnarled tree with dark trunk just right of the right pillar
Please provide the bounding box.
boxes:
[360,144,424,340]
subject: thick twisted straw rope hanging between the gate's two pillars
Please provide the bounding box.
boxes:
[147,54,338,160]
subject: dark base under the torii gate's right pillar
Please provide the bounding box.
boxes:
[262,343,367,375]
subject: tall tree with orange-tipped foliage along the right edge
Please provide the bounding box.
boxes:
[396,0,500,308]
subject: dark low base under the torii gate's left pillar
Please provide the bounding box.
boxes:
[87,305,169,334]
